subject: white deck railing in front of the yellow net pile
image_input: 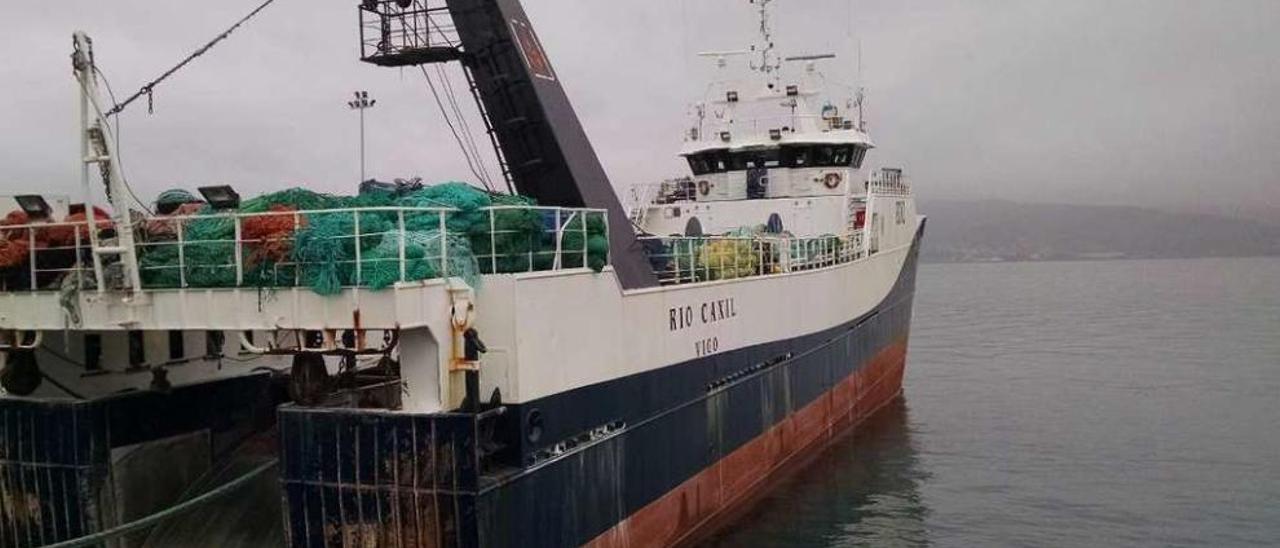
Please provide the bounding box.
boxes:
[640,232,867,284]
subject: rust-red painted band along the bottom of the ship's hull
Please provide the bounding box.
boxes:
[588,341,906,548]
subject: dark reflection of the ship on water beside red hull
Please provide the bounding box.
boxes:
[705,398,929,548]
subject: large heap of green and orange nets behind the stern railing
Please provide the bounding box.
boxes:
[127,183,608,294]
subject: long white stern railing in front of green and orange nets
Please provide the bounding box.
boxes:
[0,206,609,292]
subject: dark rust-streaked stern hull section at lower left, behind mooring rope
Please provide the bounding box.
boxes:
[0,375,283,548]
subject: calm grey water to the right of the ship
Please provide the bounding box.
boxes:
[714,259,1280,547]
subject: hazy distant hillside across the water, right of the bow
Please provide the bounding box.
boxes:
[920,200,1280,261]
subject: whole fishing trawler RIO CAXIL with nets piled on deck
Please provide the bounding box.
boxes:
[0,0,924,547]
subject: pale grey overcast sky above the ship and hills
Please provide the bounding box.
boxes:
[0,0,1280,218]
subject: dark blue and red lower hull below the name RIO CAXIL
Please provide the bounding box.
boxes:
[280,225,923,547]
